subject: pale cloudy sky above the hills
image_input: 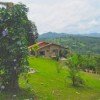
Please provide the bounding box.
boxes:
[0,0,100,34]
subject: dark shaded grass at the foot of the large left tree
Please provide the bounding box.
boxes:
[0,89,37,100]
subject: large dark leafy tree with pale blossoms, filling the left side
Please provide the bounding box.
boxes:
[0,4,36,91]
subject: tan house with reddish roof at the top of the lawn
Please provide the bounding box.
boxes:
[29,42,67,58]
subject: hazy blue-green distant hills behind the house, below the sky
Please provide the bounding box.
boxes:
[38,32,100,54]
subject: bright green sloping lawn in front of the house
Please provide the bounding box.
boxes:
[0,57,100,100]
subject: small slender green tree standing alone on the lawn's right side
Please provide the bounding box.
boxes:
[67,54,83,86]
